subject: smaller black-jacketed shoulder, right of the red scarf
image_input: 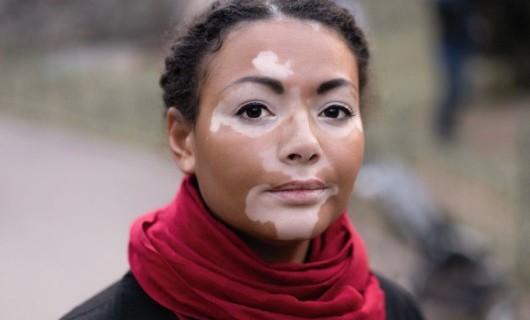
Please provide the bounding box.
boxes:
[376,274,425,320]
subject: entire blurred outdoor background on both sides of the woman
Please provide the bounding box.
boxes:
[0,0,530,319]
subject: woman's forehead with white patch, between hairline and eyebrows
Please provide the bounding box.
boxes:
[202,18,356,81]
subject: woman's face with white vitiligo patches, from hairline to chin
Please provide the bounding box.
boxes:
[177,18,364,243]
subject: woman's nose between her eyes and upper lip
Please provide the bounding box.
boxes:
[279,112,322,163]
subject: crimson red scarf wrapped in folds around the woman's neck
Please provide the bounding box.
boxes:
[129,177,385,320]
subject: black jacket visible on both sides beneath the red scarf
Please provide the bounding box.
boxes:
[60,272,423,320]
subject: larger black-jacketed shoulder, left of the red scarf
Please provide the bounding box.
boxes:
[60,272,176,320]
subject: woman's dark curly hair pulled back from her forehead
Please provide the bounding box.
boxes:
[160,0,370,123]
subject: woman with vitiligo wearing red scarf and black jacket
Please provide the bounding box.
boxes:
[63,0,421,319]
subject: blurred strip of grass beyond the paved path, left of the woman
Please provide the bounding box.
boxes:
[0,45,168,146]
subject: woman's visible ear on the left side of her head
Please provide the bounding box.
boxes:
[166,107,195,174]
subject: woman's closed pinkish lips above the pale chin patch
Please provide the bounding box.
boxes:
[268,180,328,205]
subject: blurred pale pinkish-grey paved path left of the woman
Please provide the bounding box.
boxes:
[0,114,180,320]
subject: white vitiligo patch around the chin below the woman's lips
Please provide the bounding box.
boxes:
[245,184,338,240]
